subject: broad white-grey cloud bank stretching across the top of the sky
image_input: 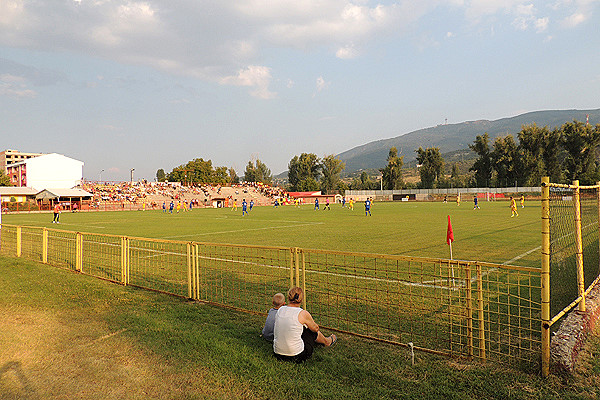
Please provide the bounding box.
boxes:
[0,0,598,99]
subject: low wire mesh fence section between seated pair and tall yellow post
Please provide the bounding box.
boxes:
[299,249,541,367]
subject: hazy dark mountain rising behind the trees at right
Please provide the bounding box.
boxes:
[336,109,600,175]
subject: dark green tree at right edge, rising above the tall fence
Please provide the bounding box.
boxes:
[561,121,600,185]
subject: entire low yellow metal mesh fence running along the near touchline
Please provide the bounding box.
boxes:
[0,225,541,369]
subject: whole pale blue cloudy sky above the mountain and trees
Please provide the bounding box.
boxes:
[0,0,600,181]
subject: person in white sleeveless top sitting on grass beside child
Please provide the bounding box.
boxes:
[273,287,337,363]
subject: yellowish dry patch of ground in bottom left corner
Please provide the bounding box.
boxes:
[0,306,247,400]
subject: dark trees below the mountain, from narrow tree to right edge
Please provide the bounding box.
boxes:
[380,121,600,189]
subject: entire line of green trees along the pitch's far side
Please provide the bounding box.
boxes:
[151,121,600,193]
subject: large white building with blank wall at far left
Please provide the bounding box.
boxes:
[7,153,83,191]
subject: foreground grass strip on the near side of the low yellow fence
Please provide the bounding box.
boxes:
[0,258,600,400]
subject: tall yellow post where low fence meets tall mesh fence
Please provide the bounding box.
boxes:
[541,176,550,378]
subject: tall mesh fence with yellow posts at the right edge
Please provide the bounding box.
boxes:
[542,177,600,376]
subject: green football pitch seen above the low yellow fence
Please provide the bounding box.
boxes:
[2,201,541,267]
